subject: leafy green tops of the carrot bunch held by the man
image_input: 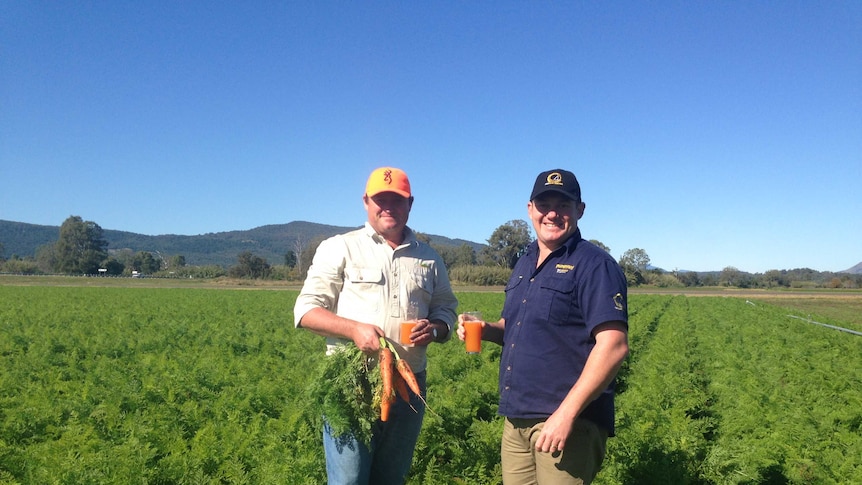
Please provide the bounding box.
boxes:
[308,343,380,444]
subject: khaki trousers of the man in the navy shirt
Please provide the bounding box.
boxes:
[500,418,608,485]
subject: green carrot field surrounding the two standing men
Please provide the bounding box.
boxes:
[0,282,862,485]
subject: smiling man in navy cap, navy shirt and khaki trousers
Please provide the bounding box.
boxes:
[458,169,628,484]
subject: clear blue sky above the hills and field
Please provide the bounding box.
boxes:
[0,0,862,272]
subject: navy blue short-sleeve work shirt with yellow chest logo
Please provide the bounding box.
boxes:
[498,230,628,436]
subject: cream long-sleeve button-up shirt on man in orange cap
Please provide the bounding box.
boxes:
[293,222,458,372]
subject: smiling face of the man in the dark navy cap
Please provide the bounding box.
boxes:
[527,192,585,251]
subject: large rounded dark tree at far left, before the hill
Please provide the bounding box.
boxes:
[55,216,108,274]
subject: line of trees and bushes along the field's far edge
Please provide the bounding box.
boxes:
[0,216,862,288]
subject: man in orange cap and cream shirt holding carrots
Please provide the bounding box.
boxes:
[294,167,458,484]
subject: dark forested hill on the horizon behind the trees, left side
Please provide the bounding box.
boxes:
[0,220,483,267]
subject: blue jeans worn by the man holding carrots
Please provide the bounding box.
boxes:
[323,372,426,485]
